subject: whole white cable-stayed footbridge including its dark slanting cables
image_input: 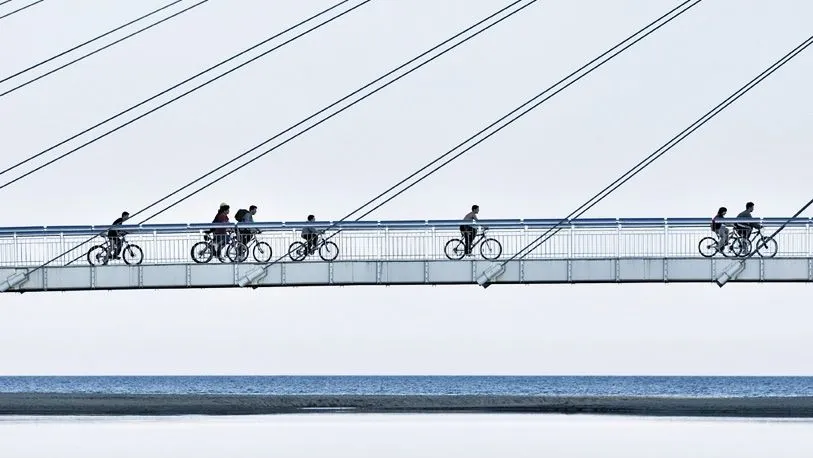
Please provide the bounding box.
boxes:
[0,0,813,292]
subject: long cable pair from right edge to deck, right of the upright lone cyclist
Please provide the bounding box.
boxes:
[501,36,813,272]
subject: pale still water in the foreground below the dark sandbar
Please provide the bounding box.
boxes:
[0,414,813,458]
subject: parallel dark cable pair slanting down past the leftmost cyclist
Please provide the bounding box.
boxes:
[36,0,539,275]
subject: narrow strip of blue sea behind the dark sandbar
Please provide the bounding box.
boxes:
[0,376,813,397]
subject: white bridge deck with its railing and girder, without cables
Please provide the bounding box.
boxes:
[0,218,813,292]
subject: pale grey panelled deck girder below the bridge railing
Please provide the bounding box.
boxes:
[0,258,813,292]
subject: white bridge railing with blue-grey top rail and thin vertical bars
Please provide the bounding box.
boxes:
[0,218,813,266]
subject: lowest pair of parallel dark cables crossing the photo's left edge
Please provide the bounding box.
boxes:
[0,0,364,189]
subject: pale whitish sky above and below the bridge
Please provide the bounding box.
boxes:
[0,0,813,375]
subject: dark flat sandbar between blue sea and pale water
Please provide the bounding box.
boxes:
[0,393,813,418]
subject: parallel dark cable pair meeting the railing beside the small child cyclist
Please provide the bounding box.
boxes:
[233,0,702,276]
